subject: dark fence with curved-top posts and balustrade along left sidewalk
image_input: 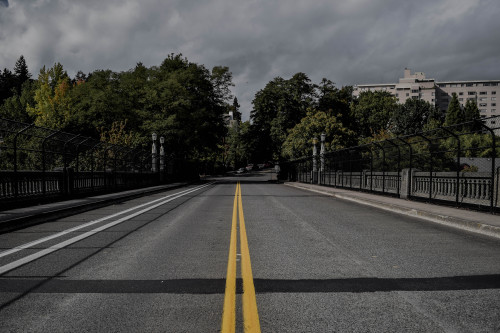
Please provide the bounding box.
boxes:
[0,118,198,205]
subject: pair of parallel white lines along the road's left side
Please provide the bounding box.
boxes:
[0,183,213,275]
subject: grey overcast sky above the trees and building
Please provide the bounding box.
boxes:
[0,0,500,120]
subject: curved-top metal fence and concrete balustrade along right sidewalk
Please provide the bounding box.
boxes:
[283,117,500,212]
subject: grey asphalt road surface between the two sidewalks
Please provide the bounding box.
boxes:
[0,174,500,332]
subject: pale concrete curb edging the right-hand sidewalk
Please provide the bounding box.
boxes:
[285,183,500,239]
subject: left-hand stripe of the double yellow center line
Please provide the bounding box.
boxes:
[221,183,238,333]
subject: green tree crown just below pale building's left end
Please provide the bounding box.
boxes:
[352,91,398,137]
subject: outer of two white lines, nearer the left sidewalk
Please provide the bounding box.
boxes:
[0,182,213,258]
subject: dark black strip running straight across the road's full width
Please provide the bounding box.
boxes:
[0,274,500,294]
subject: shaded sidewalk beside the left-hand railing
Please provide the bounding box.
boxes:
[0,183,187,233]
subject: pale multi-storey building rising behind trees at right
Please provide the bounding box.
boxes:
[353,68,500,118]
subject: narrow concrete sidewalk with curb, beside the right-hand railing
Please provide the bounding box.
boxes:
[285,182,500,238]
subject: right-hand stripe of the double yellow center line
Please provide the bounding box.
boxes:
[237,183,260,333]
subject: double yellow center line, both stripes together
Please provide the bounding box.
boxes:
[221,182,260,333]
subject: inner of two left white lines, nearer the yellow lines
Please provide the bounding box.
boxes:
[0,183,213,275]
